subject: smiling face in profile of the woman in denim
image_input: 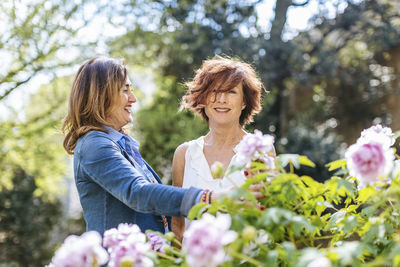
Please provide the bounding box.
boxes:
[107,78,136,130]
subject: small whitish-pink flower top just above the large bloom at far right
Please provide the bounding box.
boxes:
[357,124,395,147]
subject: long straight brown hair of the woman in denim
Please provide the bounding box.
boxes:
[62,57,127,154]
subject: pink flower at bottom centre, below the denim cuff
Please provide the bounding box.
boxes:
[182,213,237,267]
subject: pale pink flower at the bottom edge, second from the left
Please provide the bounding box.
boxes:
[103,223,153,267]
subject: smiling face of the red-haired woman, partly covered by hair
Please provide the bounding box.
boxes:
[204,83,246,127]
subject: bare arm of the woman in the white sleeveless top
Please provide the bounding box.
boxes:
[171,144,187,245]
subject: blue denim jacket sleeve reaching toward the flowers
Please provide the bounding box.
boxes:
[75,135,202,216]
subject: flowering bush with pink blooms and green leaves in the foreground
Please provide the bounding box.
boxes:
[49,125,400,267]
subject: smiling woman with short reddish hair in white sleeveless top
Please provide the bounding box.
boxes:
[172,56,270,243]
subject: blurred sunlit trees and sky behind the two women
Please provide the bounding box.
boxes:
[0,0,400,267]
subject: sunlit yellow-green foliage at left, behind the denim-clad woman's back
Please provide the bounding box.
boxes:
[0,76,70,200]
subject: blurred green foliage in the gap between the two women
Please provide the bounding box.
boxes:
[134,77,207,180]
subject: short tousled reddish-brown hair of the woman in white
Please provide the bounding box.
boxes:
[181,56,265,126]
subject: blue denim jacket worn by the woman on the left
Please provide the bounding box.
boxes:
[74,131,202,237]
